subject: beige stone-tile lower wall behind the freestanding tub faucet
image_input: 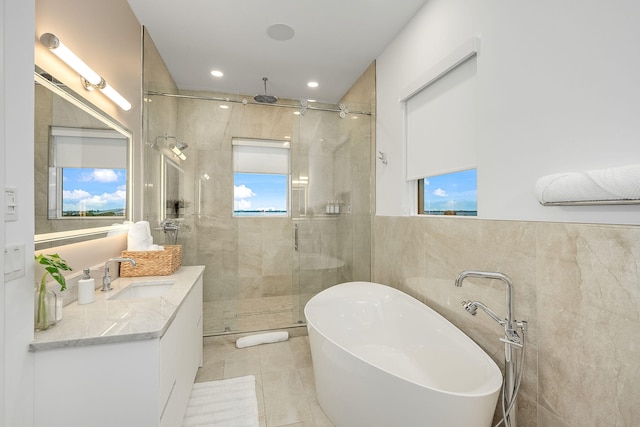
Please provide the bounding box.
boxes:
[373,217,640,427]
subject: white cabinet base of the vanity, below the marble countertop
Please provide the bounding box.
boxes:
[34,267,202,427]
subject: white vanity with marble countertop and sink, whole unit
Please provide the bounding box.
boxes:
[31,266,204,427]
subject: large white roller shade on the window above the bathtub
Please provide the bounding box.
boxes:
[405,49,477,180]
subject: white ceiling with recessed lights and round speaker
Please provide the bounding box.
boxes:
[128,0,426,102]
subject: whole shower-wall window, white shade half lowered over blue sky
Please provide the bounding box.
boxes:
[232,138,290,217]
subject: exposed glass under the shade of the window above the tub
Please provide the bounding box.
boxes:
[418,169,478,216]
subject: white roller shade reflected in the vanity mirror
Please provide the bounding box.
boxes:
[51,127,128,169]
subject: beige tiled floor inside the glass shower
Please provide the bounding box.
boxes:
[203,295,306,336]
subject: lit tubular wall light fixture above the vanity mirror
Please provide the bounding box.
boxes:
[40,33,131,111]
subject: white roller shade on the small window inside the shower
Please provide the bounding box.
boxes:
[232,138,289,174]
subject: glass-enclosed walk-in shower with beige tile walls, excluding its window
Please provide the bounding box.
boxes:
[143,30,375,335]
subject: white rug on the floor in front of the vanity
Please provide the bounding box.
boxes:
[182,375,260,427]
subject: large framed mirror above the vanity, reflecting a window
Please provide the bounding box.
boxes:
[34,67,133,249]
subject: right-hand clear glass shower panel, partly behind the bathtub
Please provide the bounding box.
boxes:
[291,104,372,323]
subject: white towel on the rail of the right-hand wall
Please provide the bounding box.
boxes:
[534,165,640,204]
